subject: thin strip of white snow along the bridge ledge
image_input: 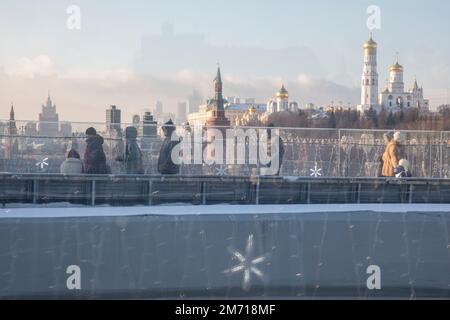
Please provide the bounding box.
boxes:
[0,204,450,219]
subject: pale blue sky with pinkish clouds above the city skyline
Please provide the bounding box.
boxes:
[0,0,450,121]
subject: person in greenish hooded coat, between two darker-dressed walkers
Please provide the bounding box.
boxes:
[116,127,144,174]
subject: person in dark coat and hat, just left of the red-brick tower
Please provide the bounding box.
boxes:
[158,120,180,174]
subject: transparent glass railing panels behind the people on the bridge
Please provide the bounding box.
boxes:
[0,120,450,178]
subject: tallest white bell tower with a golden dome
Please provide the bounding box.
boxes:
[361,33,379,110]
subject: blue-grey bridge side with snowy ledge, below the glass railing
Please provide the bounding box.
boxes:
[0,174,450,299]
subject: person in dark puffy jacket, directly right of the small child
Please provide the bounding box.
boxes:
[84,127,111,174]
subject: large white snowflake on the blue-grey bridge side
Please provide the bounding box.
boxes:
[224,234,267,291]
